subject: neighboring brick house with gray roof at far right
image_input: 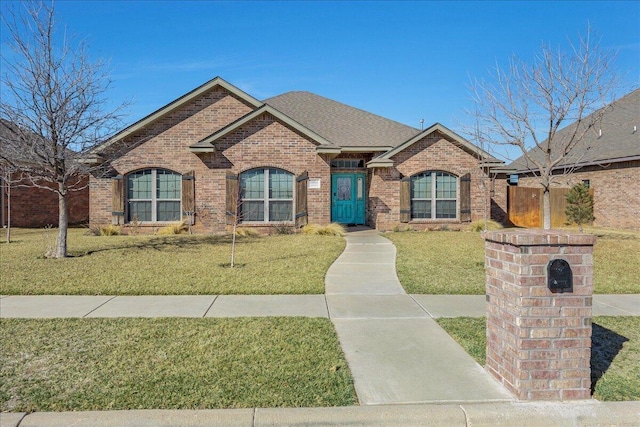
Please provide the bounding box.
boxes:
[507,89,640,230]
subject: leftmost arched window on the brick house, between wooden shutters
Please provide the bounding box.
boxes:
[126,169,182,222]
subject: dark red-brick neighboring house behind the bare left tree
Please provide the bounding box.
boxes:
[0,120,89,228]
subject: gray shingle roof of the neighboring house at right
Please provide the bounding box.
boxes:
[507,89,640,172]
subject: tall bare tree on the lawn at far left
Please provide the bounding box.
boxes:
[0,2,122,258]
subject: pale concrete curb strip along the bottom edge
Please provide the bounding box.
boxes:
[0,401,640,427]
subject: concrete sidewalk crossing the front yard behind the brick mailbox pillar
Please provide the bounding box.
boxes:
[0,296,640,319]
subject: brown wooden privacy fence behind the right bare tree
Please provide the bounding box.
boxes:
[507,187,593,228]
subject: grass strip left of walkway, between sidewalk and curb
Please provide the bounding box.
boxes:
[0,318,357,412]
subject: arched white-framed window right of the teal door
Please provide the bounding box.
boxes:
[411,171,458,219]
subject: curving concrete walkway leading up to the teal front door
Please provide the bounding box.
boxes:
[325,230,512,405]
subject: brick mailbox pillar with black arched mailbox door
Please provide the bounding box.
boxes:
[484,230,595,400]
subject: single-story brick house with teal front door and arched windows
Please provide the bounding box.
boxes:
[90,78,506,232]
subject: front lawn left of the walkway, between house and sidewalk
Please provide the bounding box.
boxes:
[0,229,345,295]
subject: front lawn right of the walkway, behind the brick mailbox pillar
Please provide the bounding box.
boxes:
[385,230,640,295]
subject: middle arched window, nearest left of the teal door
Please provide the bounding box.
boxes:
[240,169,293,222]
